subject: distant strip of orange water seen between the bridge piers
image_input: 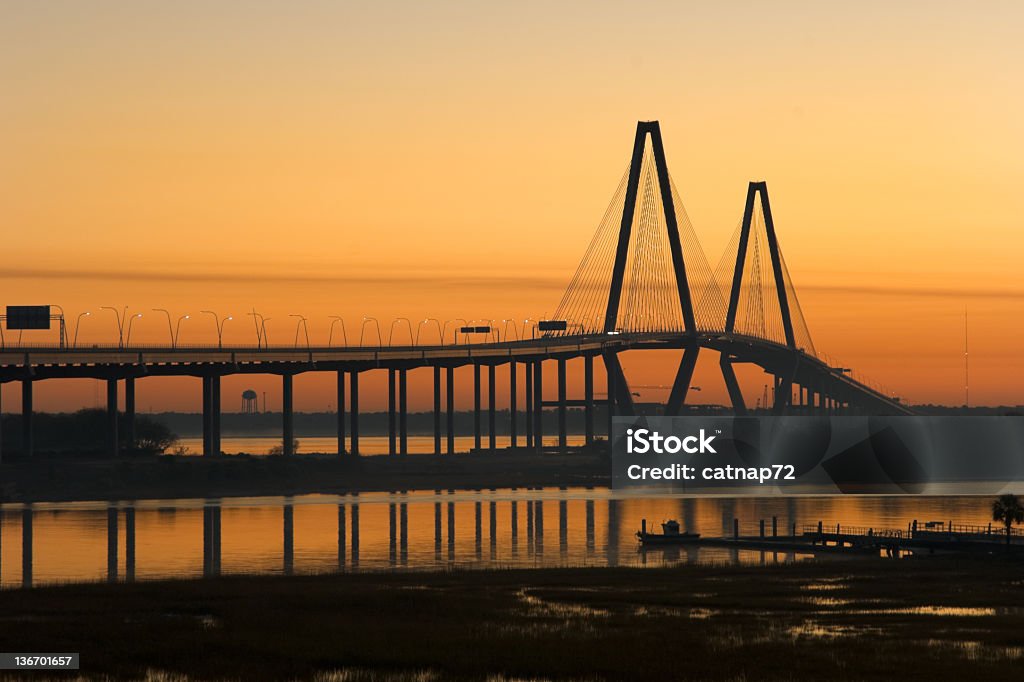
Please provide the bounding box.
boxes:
[178,435,584,455]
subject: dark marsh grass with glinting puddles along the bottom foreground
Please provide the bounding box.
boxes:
[0,559,1024,681]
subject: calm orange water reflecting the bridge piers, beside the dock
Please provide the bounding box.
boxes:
[0,488,1007,588]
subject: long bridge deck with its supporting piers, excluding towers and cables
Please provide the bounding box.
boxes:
[0,332,910,456]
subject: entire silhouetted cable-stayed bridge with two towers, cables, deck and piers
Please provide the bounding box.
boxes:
[0,122,910,456]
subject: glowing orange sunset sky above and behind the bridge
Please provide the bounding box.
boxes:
[0,0,1024,411]
